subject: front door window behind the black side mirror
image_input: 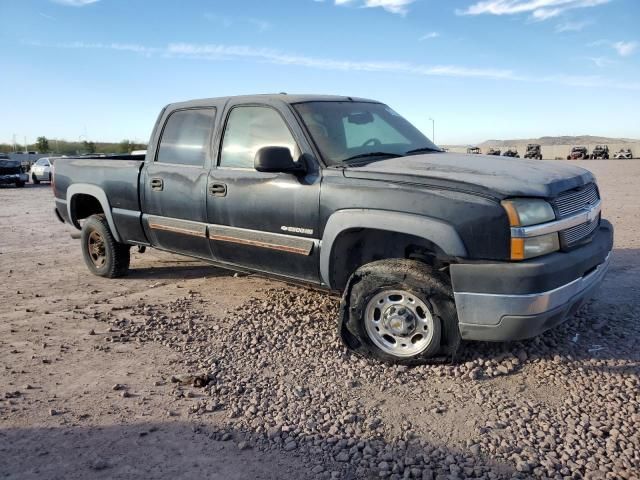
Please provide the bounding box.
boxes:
[220,107,297,168]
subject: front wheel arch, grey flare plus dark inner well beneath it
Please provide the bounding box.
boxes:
[320,209,466,290]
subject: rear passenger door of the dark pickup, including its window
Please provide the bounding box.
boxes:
[142,108,216,259]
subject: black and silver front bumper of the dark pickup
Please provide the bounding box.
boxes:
[451,220,613,341]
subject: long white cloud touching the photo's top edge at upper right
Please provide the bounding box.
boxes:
[456,0,612,20]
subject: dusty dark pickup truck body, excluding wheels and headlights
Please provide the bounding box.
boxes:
[54,95,613,341]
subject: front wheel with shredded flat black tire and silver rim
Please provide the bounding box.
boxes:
[345,259,459,365]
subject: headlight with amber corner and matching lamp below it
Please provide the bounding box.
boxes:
[502,198,560,260]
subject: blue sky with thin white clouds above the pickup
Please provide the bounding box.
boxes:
[0,0,640,144]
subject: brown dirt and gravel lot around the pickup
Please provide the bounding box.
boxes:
[0,161,640,480]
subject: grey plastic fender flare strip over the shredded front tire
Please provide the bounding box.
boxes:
[320,209,467,288]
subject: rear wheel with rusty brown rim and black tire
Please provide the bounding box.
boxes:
[80,215,131,278]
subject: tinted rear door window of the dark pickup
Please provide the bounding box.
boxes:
[156,108,216,167]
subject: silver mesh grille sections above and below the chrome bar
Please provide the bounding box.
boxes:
[551,183,600,248]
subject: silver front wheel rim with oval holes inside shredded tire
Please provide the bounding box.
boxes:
[364,290,434,357]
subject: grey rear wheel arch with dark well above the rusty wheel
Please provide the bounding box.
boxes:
[67,183,120,242]
